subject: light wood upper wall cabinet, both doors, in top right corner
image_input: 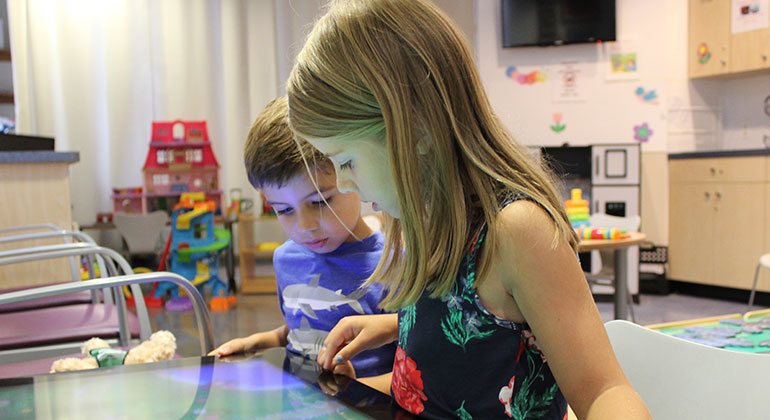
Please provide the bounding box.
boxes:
[687,0,770,78]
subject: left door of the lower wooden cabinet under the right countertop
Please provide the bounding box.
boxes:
[669,182,716,284]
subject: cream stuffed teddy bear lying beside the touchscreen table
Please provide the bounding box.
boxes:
[50,330,176,373]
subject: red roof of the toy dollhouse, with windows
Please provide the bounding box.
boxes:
[142,120,219,170]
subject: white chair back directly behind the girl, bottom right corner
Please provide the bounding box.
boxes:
[604,320,770,420]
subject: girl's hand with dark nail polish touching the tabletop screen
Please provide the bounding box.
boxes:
[318,314,398,370]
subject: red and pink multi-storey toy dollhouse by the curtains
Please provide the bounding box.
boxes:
[112,121,222,213]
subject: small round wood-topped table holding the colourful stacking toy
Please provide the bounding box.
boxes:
[578,232,647,319]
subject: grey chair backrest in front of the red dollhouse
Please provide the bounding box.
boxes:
[112,210,168,259]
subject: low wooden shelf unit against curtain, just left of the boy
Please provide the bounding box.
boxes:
[238,213,286,294]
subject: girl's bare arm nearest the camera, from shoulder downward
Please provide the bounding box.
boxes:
[488,200,650,419]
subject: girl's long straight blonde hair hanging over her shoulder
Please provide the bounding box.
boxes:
[287,0,577,309]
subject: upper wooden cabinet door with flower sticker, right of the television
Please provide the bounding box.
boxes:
[687,0,731,78]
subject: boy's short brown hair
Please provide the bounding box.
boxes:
[243,96,334,188]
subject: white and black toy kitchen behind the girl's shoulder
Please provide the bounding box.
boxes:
[536,144,641,296]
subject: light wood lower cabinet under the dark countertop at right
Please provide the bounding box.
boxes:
[669,156,770,291]
